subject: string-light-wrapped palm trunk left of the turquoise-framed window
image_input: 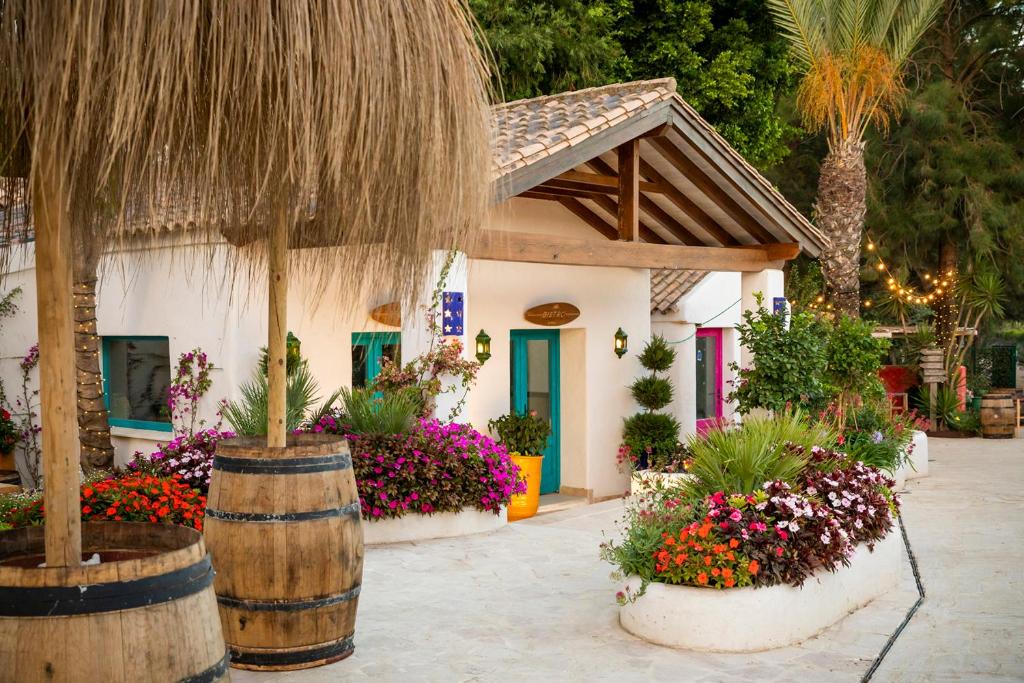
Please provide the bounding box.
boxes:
[74,240,114,471]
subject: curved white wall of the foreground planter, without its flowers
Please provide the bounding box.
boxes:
[618,528,902,652]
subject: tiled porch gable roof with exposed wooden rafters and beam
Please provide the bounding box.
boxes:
[467,79,826,271]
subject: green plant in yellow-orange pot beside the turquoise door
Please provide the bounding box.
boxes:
[487,411,551,521]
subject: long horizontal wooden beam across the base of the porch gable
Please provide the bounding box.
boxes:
[466,230,784,272]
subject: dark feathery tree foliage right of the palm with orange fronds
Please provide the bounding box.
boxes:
[865,0,1024,327]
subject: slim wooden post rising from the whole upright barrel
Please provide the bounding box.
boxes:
[266,205,288,449]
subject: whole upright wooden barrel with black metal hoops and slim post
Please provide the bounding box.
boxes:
[204,434,362,671]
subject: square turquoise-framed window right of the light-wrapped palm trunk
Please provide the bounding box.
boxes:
[102,337,172,432]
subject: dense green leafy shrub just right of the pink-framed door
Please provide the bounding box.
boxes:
[729,293,827,414]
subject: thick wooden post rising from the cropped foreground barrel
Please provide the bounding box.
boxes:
[32,150,82,566]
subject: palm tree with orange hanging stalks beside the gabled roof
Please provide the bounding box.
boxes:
[768,0,941,315]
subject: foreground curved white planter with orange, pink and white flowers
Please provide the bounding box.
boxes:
[602,415,898,650]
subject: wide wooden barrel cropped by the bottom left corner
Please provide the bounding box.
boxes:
[0,522,228,683]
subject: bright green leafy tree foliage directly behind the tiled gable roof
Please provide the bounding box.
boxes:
[470,0,794,166]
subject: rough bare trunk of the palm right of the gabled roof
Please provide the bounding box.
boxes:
[814,139,867,316]
